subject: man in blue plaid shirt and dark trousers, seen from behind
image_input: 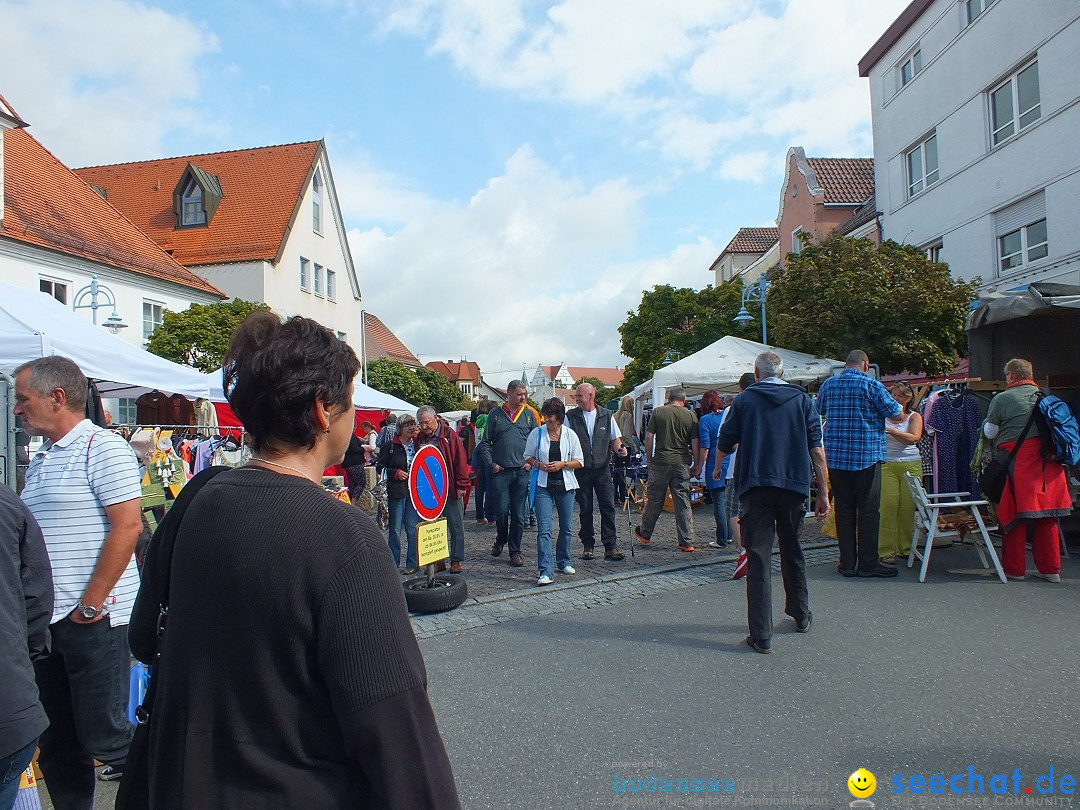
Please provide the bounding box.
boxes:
[818,349,903,577]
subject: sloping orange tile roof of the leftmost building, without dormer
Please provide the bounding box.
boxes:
[0,130,226,298]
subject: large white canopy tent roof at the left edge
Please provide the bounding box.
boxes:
[0,282,210,400]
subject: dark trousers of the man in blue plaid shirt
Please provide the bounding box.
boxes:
[828,464,881,571]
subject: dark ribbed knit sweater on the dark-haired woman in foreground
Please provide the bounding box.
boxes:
[131,468,459,810]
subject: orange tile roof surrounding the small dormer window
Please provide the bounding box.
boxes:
[76,140,322,267]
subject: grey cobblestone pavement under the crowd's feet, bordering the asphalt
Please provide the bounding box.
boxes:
[413,498,838,638]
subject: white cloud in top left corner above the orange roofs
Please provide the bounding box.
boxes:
[0,0,218,165]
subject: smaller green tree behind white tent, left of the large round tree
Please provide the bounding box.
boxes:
[612,279,772,396]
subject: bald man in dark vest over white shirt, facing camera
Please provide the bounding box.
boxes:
[566,382,626,561]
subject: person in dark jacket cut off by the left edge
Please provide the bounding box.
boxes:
[0,486,53,810]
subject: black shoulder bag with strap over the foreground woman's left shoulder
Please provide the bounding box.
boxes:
[116,467,231,810]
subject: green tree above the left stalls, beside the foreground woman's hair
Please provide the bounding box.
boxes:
[147,298,270,372]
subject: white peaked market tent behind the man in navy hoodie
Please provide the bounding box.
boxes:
[631,335,843,405]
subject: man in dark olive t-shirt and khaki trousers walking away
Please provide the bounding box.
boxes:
[634,388,700,552]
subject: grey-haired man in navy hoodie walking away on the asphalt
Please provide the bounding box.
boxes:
[713,352,828,652]
